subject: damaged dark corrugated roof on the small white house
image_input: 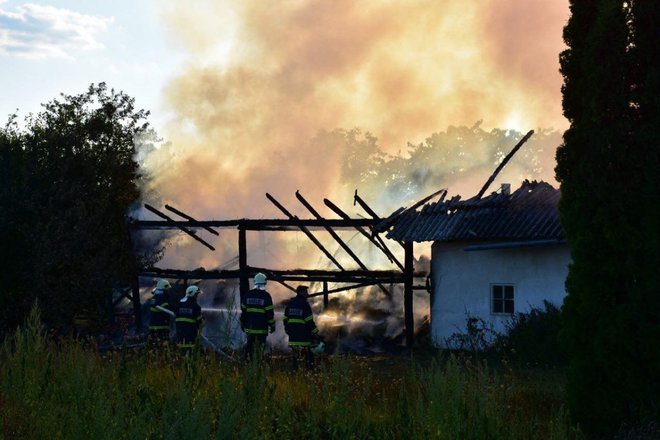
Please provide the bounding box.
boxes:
[387,180,564,242]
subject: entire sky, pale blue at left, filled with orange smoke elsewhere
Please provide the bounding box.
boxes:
[0,0,569,264]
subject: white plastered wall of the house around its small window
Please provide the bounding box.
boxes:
[431,242,570,347]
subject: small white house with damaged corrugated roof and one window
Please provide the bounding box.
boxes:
[378,181,570,347]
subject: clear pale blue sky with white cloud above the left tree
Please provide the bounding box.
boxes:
[0,0,184,125]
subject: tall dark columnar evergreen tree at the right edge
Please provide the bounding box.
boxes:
[556,0,660,435]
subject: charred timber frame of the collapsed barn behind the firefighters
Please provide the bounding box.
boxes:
[126,191,427,347]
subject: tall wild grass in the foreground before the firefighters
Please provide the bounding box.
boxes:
[0,310,580,439]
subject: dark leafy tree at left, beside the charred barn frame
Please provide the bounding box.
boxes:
[0,83,158,329]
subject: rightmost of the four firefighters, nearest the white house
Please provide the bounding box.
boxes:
[284,286,322,370]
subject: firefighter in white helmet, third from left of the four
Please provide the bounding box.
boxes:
[241,273,275,360]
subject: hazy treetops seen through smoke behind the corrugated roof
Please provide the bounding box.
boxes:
[312,121,561,212]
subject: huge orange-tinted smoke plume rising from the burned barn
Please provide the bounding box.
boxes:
[137,0,569,350]
